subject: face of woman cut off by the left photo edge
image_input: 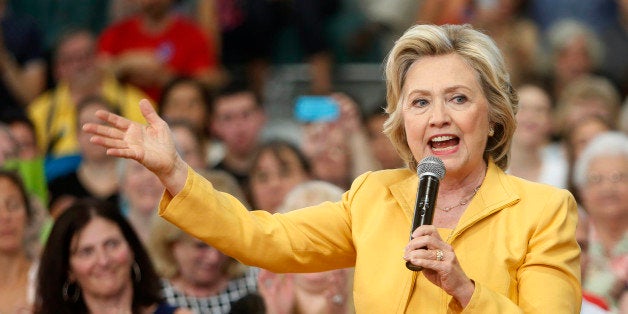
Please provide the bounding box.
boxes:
[0,177,28,255]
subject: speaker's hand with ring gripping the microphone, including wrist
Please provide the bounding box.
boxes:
[403,225,475,307]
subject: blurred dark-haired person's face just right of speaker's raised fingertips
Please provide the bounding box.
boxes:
[161,81,207,131]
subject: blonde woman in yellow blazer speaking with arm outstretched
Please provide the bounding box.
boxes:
[84,25,581,313]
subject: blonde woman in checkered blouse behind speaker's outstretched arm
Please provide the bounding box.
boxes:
[148,171,257,313]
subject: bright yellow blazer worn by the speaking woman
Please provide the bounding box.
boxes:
[159,162,581,314]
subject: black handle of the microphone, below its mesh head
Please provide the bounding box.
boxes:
[406,175,439,271]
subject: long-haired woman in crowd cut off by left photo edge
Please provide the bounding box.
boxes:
[0,170,38,313]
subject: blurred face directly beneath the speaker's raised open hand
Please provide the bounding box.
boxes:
[120,160,164,214]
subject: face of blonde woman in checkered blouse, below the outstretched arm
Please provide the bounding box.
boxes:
[172,235,228,286]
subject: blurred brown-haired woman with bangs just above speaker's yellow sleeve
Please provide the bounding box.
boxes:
[248,140,311,213]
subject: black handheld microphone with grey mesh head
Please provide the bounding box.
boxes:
[406,156,445,271]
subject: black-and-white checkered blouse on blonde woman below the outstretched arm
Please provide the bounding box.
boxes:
[161,267,259,314]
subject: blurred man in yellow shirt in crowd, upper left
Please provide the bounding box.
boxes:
[28,29,147,180]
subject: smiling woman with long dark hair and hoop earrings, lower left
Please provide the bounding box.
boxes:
[35,199,184,313]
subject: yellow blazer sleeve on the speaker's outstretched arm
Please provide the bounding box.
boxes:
[159,168,355,272]
